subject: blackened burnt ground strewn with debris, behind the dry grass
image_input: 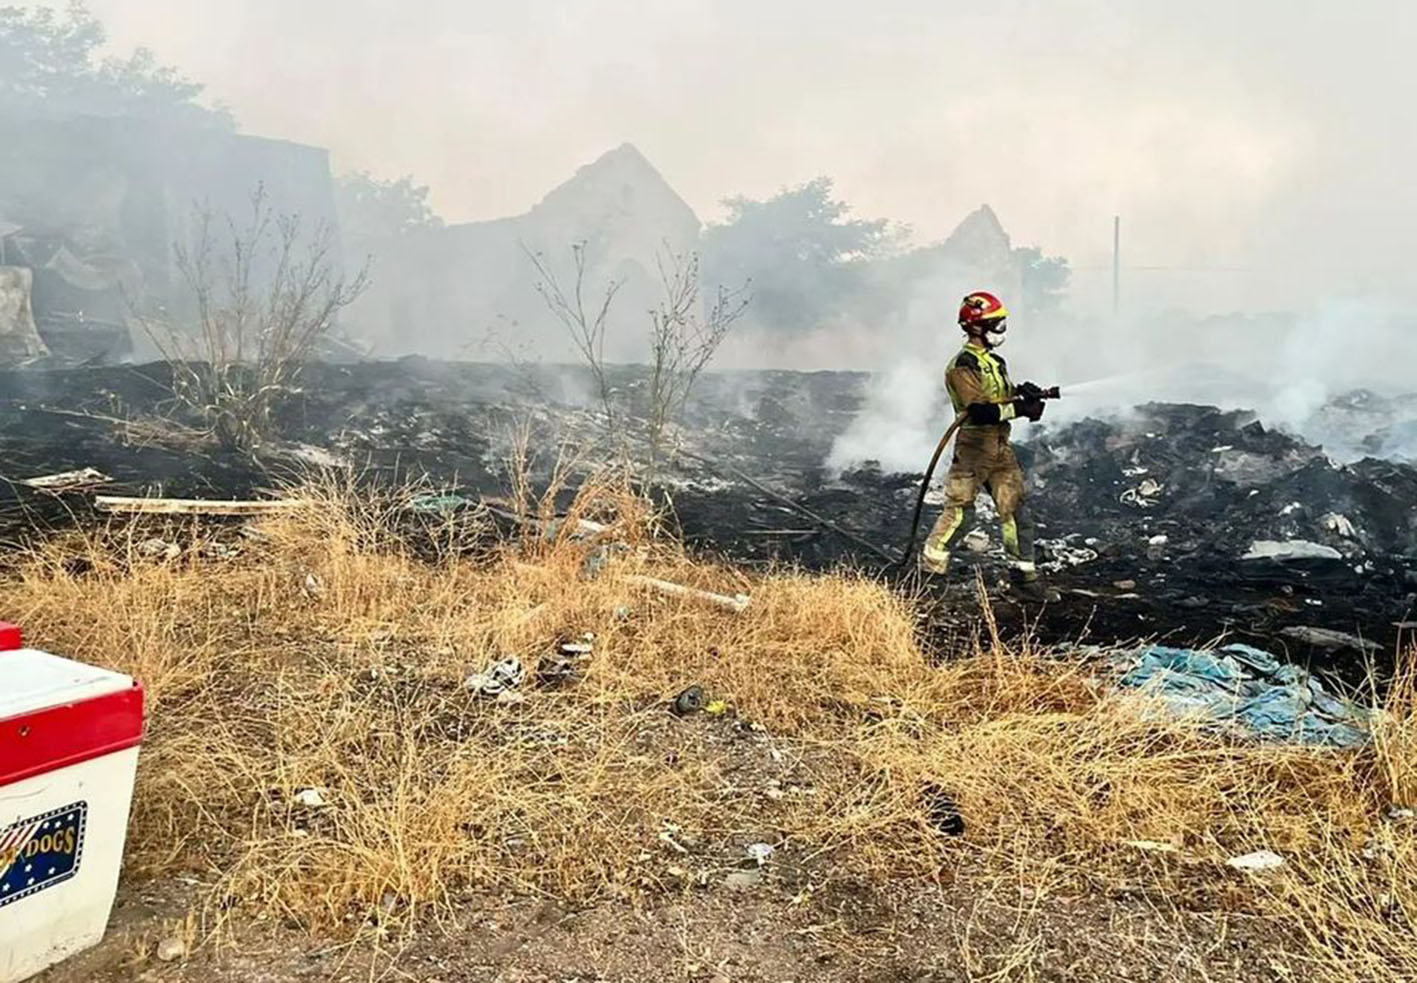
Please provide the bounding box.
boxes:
[0,358,1417,678]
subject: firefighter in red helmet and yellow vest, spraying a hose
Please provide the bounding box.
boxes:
[921,290,1053,601]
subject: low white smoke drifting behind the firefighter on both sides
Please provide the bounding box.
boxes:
[826,299,1417,472]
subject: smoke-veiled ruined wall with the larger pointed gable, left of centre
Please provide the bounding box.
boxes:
[346,144,700,361]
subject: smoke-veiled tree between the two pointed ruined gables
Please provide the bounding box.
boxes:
[704,177,903,330]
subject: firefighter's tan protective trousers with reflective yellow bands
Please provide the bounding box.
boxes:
[921,424,1036,578]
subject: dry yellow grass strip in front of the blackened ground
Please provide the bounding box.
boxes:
[0,484,1417,980]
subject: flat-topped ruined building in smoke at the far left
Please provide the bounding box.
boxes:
[0,118,334,362]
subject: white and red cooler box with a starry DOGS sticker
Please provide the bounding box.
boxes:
[0,623,143,983]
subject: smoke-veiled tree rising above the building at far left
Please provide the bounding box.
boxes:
[0,0,234,129]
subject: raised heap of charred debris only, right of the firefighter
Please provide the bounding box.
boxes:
[1024,404,1417,572]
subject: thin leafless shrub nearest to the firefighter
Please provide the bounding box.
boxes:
[646,245,750,467]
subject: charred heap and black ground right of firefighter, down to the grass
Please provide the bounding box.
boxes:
[997,404,1417,663]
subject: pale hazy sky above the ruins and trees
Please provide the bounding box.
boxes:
[71,0,1417,308]
